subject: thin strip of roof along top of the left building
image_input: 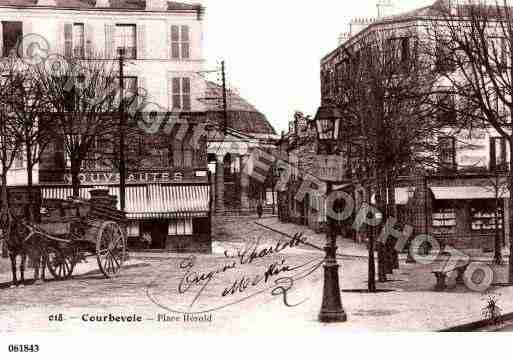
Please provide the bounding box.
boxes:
[0,0,202,11]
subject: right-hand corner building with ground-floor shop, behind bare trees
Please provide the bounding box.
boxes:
[321,0,511,251]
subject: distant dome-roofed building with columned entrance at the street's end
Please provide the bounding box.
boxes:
[205,82,279,214]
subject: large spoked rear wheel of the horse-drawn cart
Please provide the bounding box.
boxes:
[96,222,126,278]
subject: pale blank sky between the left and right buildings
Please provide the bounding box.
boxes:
[196,0,435,134]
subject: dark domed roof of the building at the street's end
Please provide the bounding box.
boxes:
[203,81,276,135]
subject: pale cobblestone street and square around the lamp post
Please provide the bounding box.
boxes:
[0,214,513,334]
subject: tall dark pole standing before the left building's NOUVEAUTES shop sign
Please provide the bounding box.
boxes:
[119,48,126,212]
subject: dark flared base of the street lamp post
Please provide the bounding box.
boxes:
[319,263,347,323]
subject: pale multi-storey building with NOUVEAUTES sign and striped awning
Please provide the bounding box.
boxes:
[0,0,211,252]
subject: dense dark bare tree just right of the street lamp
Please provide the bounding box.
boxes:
[334,28,440,291]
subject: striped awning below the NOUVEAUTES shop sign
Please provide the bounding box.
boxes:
[42,184,210,219]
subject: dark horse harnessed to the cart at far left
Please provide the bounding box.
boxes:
[0,210,47,288]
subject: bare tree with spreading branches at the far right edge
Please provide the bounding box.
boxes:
[426,0,513,283]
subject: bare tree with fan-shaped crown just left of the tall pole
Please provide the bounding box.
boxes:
[34,56,120,196]
